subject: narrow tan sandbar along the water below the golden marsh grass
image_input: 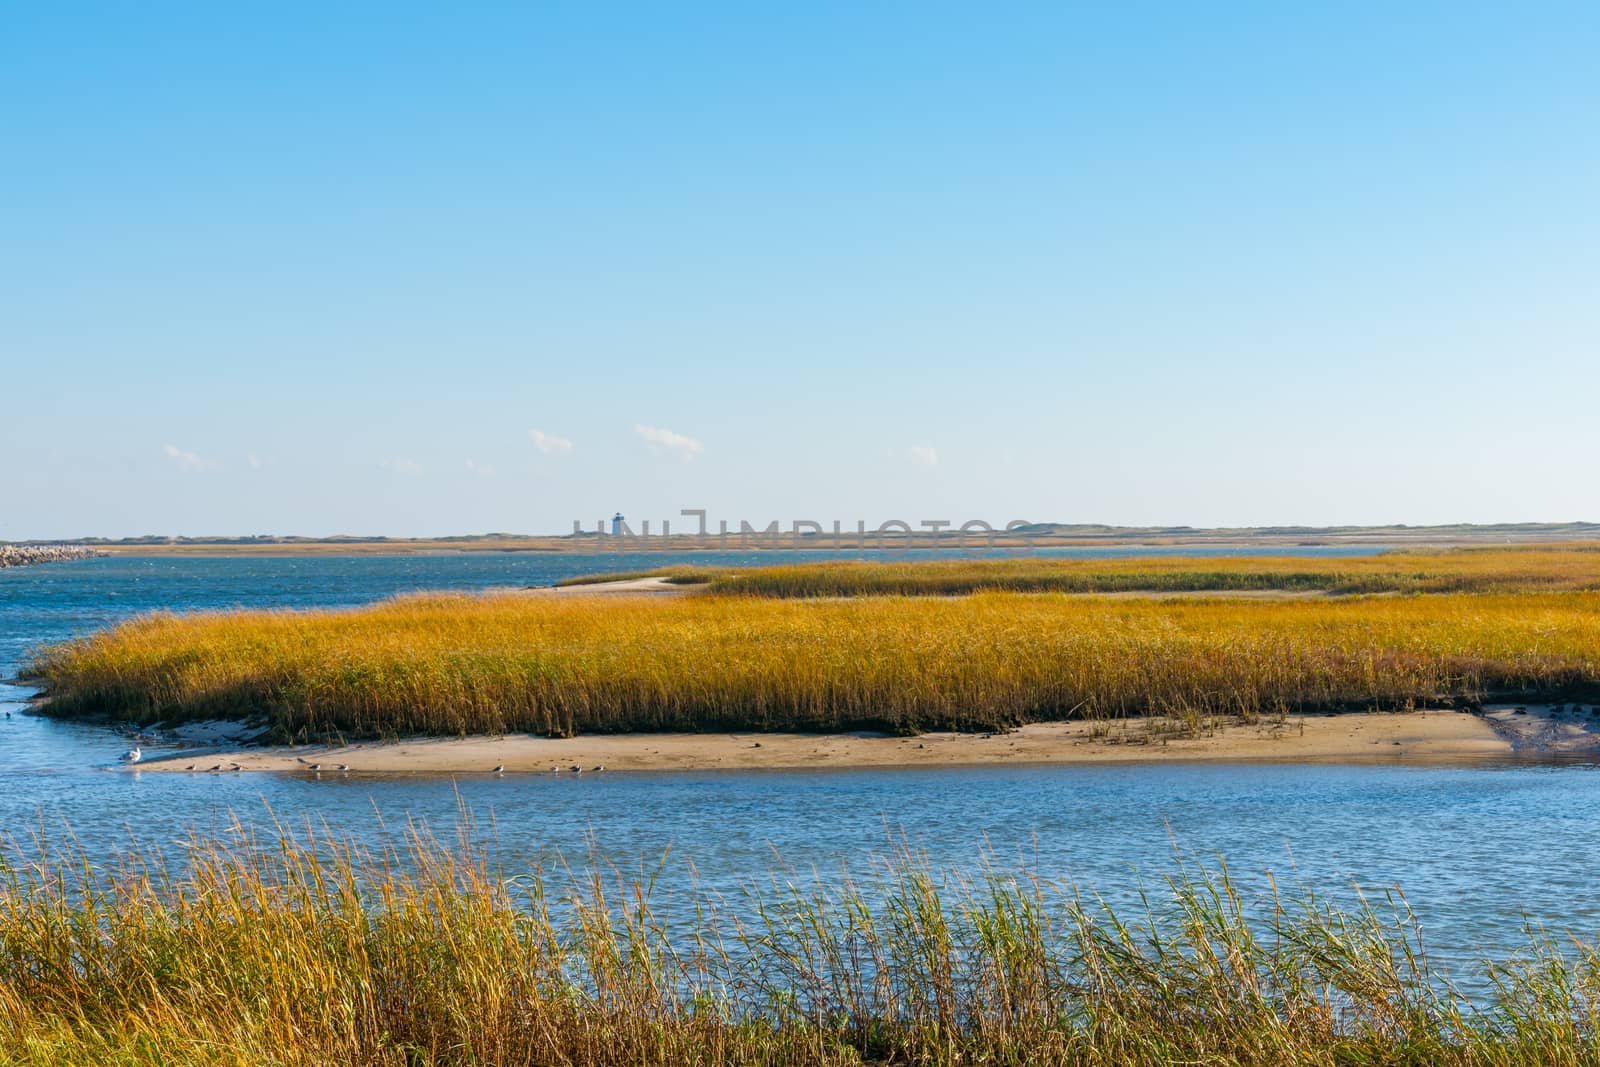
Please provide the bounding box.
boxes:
[141,705,1600,774]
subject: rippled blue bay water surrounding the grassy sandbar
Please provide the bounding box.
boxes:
[0,549,1600,979]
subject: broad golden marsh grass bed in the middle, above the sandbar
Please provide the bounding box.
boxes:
[18,593,1600,739]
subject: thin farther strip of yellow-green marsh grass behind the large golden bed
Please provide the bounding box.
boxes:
[563,545,1600,597]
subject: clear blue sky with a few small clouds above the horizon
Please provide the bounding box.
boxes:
[0,2,1600,539]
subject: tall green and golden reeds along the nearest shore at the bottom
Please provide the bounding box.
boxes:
[0,837,1600,1067]
